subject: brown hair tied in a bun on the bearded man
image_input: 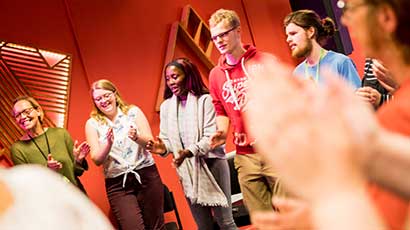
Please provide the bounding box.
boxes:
[283,10,336,45]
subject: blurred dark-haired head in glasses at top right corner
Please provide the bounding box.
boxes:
[338,0,410,64]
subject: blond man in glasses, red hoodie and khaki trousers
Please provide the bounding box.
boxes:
[209,9,282,214]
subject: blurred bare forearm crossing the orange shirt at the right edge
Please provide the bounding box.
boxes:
[368,131,410,199]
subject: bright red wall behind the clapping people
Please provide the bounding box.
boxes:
[0,0,362,229]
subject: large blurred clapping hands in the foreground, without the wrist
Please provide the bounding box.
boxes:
[247,60,376,200]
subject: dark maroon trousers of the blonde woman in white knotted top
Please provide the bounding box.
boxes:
[105,165,165,230]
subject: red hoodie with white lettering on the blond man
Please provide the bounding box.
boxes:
[209,45,274,154]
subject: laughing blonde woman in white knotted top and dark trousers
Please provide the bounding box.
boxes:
[86,79,164,230]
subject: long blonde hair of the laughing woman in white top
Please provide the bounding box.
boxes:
[90,79,130,124]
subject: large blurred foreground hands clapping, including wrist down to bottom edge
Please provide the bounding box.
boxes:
[247,61,383,229]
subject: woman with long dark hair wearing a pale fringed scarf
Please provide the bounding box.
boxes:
[147,58,237,230]
